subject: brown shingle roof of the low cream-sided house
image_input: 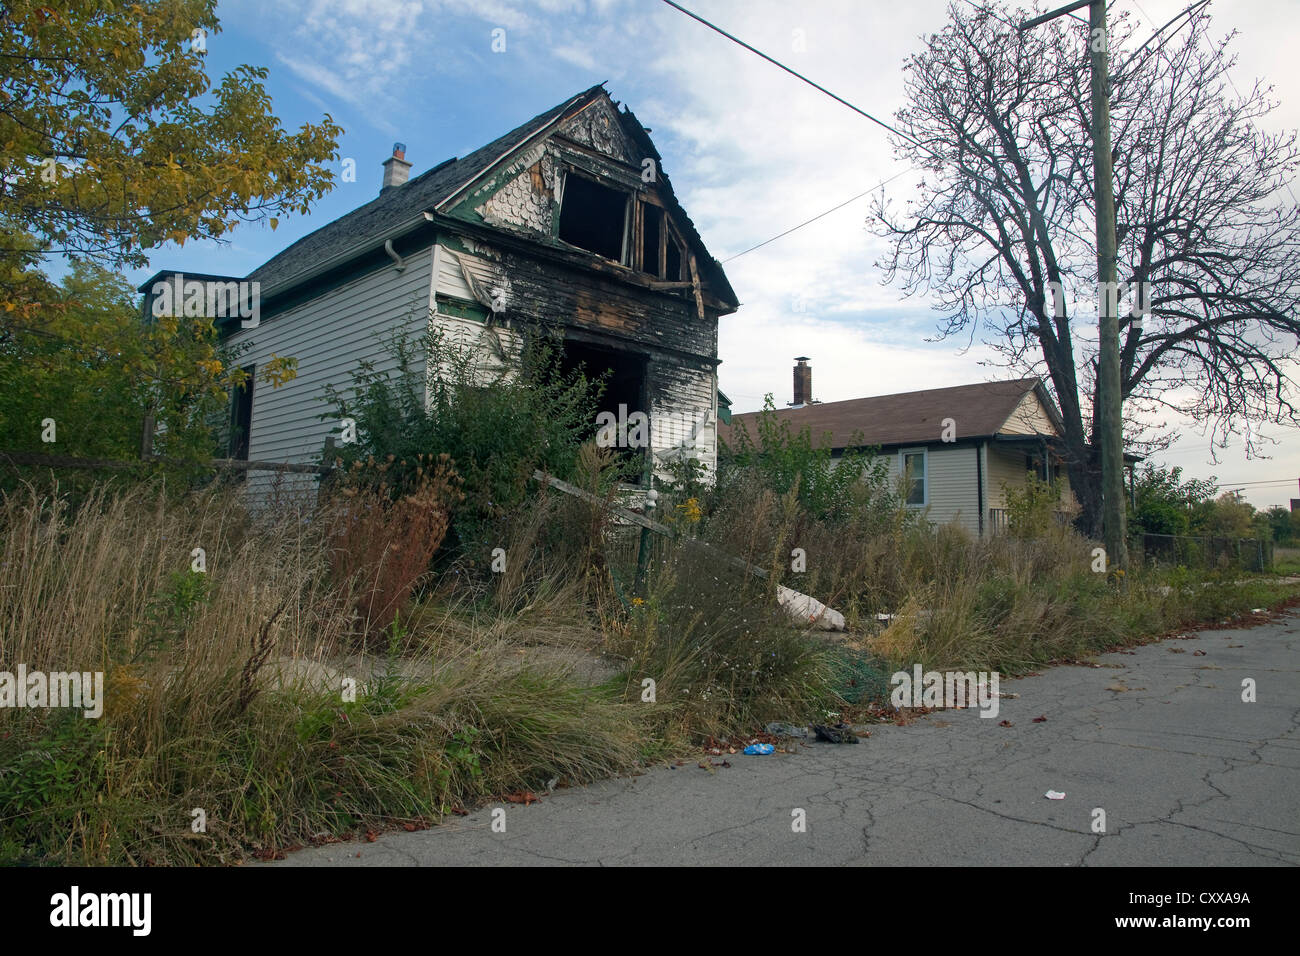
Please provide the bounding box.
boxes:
[718,378,1056,449]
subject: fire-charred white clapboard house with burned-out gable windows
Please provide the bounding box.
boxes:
[140,86,738,496]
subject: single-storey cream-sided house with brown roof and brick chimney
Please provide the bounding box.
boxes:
[720,356,1074,536]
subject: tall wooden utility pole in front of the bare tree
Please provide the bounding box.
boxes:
[1021,0,1140,570]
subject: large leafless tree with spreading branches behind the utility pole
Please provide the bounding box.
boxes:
[875,4,1300,533]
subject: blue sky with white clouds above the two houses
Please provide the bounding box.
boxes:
[133,0,1300,506]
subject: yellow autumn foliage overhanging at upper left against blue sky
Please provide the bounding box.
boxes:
[0,0,341,321]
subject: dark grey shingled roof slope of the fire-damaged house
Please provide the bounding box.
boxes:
[248,86,603,287]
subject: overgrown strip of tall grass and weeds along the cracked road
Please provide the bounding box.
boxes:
[0,476,1286,865]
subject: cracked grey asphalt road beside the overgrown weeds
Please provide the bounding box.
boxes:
[272,613,1300,866]
